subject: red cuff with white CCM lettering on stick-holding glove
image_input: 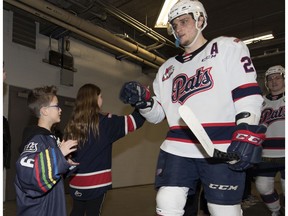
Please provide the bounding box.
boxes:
[232,130,265,146]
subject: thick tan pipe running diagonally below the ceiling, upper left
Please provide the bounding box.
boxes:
[12,0,165,66]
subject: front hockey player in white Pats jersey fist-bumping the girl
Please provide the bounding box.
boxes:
[120,0,266,216]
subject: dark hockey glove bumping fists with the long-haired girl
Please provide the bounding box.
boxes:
[120,81,153,109]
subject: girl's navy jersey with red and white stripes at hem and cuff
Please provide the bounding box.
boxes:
[69,110,145,200]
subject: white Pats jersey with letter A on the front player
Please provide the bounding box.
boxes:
[140,37,263,158]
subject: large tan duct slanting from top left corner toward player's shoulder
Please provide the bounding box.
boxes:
[4,0,165,68]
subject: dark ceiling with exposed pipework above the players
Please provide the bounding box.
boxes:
[4,0,285,73]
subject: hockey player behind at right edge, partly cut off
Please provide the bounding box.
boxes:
[255,65,285,216]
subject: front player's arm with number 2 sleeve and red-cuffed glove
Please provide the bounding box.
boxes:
[227,38,266,171]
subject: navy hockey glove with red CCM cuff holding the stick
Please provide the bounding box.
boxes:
[227,123,267,171]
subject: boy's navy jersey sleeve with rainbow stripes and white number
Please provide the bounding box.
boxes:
[16,136,69,197]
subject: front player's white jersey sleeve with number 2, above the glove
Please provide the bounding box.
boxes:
[225,38,263,121]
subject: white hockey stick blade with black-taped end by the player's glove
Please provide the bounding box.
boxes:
[178,105,239,160]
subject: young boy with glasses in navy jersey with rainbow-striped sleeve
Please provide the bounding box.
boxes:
[15,86,77,216]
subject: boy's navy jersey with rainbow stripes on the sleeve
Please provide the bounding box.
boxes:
[15,126,70,216]
